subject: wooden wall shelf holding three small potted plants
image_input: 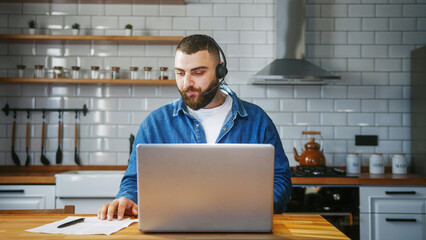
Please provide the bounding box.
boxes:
[0,34,183,45]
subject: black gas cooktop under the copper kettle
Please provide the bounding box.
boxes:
[292,166,358,177]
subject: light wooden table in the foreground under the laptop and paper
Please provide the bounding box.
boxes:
[0,214,349,240]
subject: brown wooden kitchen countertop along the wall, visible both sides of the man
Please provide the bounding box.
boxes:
[0,166,426,186]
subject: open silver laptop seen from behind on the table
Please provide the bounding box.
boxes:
[137,144,274,232]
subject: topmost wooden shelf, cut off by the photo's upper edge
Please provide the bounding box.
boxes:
[0,0,185,5]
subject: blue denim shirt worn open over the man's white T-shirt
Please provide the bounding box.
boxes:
[116,86,292,213]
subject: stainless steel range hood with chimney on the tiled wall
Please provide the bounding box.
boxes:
[252,0,340,84]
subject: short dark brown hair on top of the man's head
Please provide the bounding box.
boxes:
[176,34,220,62]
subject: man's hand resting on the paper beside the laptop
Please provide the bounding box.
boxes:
[98,197,138,221]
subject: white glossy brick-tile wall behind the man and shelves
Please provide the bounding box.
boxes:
[0,0,426,166]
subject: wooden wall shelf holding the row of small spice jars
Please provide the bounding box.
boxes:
[0,78,176,86]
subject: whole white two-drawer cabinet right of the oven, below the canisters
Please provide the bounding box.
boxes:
[360,186,426,240]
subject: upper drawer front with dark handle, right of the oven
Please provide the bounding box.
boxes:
[359,187,426,213]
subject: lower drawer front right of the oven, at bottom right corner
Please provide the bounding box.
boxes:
[360,214,426,240]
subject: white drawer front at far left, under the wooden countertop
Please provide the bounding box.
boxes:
[0,185,55,209]
